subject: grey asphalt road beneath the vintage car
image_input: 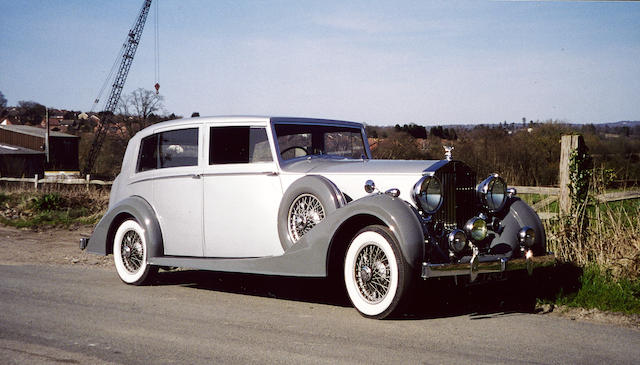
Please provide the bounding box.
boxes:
[0,265,640,364]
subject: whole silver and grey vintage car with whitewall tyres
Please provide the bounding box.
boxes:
[80,116,553,318]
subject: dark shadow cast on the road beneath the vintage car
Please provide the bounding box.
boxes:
[149,267,580,320]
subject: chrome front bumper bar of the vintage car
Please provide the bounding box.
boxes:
[422,253,556,281]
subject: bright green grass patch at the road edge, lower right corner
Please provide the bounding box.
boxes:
[556,265,640,314]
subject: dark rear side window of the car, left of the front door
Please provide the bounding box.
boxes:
[136,128,198,172]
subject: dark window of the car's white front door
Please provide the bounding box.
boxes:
[209,127,272,165]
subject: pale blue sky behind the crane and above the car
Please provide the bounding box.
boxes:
[0,0,640,125]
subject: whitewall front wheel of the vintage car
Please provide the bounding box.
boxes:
[344,225,411,319]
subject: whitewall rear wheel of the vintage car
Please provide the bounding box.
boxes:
[113,220,158,285]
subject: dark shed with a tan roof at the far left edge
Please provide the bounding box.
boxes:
[0,125,80,176]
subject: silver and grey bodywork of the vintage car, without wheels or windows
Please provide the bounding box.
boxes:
[81,116,549,279]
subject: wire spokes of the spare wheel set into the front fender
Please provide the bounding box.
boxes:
[287,194,325,242]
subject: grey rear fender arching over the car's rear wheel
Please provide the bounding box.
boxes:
[87,196,164,257]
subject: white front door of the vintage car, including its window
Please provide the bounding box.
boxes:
[203,126,283,258]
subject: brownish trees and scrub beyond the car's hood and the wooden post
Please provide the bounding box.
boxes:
[367,120,640,186]
